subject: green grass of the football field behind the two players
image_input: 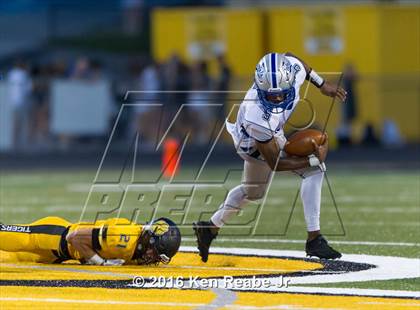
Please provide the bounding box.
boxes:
[0,166,420,291]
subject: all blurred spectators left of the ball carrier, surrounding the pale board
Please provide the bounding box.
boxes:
[5,55,231,151]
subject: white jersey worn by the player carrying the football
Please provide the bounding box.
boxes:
[226,56,306,160]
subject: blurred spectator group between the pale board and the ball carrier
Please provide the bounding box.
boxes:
[124,54,231,148]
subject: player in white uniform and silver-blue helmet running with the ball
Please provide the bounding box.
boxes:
[193,53,346,262]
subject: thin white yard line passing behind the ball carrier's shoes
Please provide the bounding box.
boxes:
[182,237,420,247]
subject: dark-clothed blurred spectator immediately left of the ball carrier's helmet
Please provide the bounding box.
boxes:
[215,54,231,122]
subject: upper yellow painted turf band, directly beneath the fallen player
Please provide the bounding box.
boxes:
[0,253,323,280]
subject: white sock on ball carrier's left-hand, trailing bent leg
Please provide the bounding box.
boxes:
[210,185,247,227]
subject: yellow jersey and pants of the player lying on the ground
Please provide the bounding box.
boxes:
[0,216,144,264]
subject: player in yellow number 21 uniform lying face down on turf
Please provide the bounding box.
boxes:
[0,217,181,266]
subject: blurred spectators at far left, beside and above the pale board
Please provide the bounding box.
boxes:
[5,57,108,151]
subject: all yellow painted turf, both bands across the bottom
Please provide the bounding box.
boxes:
[0,252,420,310]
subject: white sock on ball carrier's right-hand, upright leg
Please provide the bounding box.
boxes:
[300,172,324,231]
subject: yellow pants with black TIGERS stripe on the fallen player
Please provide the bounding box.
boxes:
[0,216,71,263]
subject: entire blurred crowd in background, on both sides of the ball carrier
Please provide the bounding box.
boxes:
[5,54,403,152]
